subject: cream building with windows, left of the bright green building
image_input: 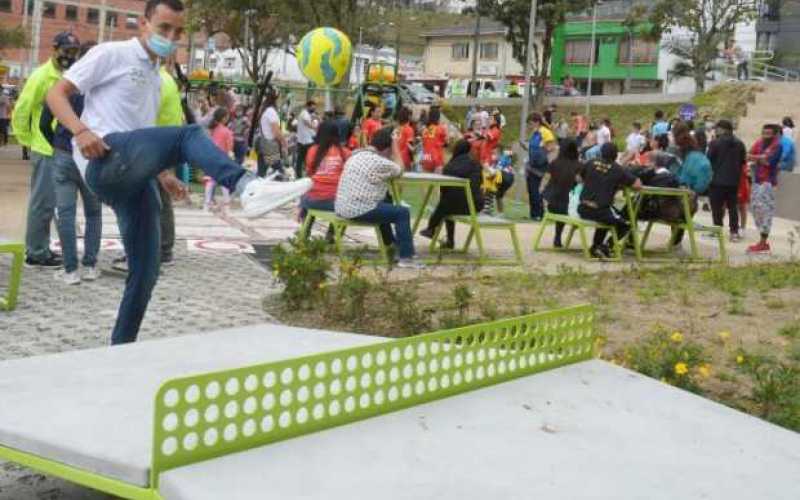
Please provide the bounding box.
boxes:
[421,19,541,80]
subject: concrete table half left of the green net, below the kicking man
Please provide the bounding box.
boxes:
[0,325,384,486]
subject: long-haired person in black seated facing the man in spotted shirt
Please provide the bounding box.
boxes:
[419,139,484,249]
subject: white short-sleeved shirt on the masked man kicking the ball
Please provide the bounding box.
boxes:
[64,38,161,176]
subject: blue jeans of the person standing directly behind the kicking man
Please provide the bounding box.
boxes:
[50,150,103,273]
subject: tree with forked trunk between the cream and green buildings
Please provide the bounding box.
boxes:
[478,0,592,105]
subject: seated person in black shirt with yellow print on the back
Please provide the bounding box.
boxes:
[578,143,642,258]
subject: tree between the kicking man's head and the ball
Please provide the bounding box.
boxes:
[189,0,292,142]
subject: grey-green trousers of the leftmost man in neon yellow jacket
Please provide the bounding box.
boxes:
[25,152,56,261]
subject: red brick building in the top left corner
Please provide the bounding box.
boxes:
[0,0,195,78]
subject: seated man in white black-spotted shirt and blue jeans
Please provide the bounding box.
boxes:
[334,127,424,269]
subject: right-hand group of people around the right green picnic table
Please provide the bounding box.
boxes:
[526,108,795,257]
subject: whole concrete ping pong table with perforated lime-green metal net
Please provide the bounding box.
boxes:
[0,306,800,500]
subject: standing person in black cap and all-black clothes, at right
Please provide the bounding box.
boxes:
[708,120,747,243]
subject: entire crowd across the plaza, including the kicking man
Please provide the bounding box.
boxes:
[6,0,794,344]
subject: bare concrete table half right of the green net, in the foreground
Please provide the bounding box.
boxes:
[160,361,800,500]
